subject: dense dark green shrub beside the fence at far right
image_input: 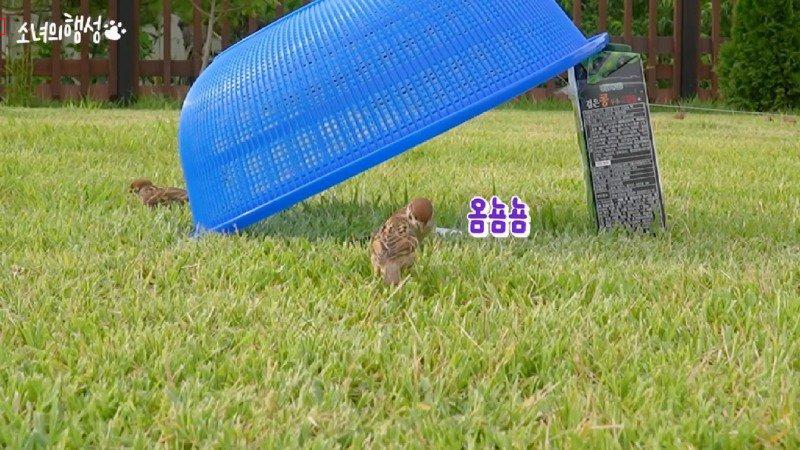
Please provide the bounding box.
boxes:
[719,0,800,111]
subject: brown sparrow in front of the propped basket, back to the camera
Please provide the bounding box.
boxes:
[370,198,435,285]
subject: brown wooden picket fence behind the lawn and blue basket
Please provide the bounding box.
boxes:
[0,0,724,102]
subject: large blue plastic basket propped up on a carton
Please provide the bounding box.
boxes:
[179,0,608,232]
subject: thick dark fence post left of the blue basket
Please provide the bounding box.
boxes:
[111,1,139,103]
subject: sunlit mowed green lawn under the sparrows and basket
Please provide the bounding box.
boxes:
[0,108,800,448]
